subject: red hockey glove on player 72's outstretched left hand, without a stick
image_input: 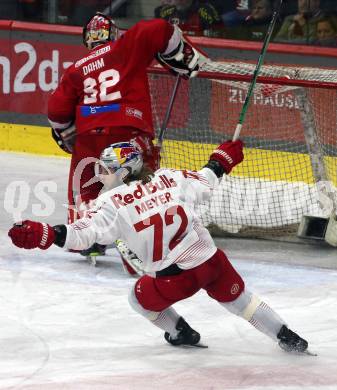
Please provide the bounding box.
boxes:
[8,220,55,249]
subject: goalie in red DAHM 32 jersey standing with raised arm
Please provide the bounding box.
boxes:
[48,13,200,266]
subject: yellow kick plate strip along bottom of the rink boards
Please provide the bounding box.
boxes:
[0,123,337,185]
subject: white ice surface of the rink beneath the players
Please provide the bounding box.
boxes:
[0,153,337,390]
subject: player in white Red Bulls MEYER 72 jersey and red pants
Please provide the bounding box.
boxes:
[9,141,308,352]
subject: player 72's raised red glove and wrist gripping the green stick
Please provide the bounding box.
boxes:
[205,140,244,178]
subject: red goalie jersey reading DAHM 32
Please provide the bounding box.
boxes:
[48,19,173,135]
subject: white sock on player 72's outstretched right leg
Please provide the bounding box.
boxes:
[220,290,286,341]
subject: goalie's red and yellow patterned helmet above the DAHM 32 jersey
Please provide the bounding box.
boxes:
[83,12,119,50]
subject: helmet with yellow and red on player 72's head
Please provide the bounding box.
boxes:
[95,142,143,180]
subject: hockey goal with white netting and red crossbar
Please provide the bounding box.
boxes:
[149,61,337,237]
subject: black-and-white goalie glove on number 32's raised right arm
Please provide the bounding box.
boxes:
[157,26,206,79]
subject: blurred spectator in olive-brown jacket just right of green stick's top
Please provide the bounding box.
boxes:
[275,0,323,44]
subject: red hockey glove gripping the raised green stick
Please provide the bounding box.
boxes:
[209,140,243,174]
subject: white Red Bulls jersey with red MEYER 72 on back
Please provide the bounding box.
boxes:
[65,168,219,273]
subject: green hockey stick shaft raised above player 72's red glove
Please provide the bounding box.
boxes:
[233,0,283,141]
